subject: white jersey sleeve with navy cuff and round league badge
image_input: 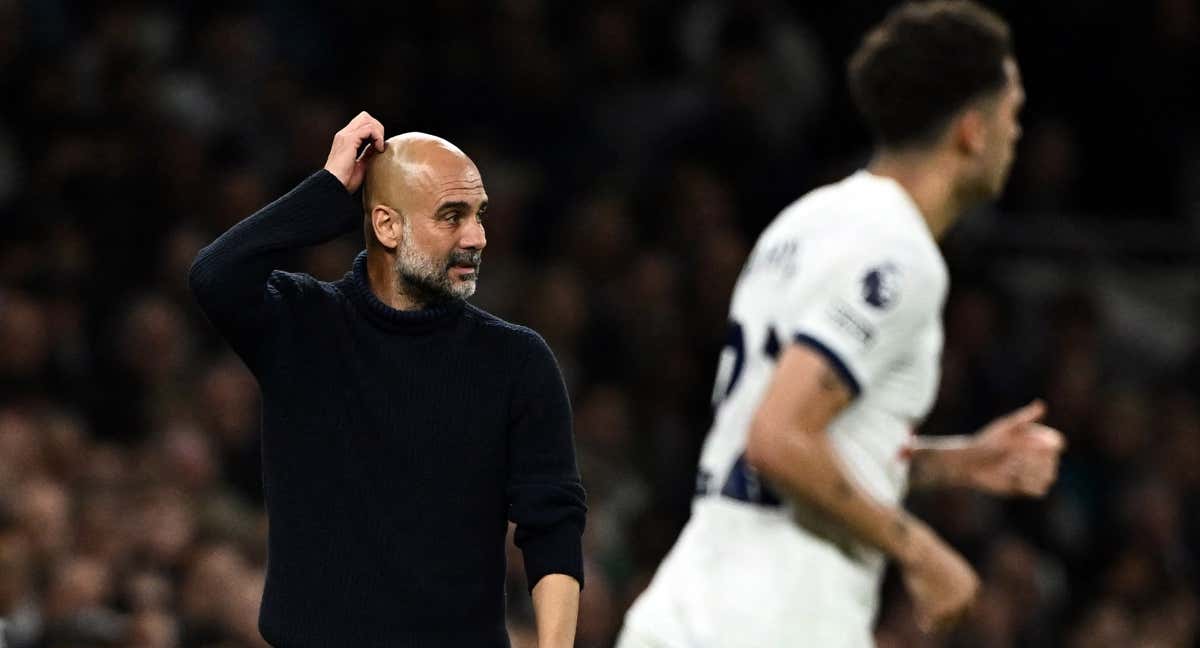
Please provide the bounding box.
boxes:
[781,236,944,396]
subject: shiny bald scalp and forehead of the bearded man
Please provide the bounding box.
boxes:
[362,132,484,223]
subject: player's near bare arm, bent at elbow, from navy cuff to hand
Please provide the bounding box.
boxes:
[746,344,978,630]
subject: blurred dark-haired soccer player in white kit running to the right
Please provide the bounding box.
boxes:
[618,1,1062,648]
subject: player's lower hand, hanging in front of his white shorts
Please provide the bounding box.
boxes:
[900,523,979,635]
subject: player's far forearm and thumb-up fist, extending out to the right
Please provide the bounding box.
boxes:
[910,401,1064,497]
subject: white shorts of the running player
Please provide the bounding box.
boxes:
[617,496,883,648]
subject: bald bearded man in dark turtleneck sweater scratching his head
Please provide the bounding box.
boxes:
[190,113,586,648]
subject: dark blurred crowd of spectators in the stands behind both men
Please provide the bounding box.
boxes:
[0,0,1200,648]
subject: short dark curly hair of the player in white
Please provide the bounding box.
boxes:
[847,0,1012,149]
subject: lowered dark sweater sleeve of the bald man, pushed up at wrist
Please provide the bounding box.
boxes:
[508,335,587,589]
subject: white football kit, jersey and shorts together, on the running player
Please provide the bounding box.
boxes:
[626,170,948,647]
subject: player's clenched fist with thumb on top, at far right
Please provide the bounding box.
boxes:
[966,401,1066,497]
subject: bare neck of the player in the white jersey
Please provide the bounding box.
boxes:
[866,151,967,240]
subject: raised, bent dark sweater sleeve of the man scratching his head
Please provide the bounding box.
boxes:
[188,169,361,373]
